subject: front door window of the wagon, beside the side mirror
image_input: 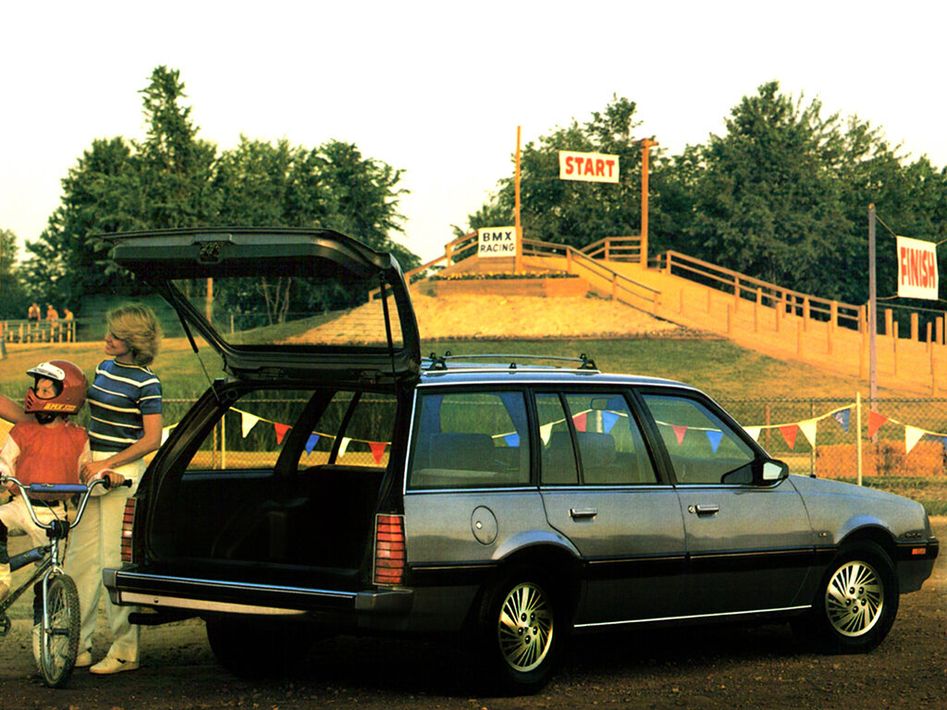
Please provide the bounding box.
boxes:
[644,394,756,483]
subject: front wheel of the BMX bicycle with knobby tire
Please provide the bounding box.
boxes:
[37,574,79,688]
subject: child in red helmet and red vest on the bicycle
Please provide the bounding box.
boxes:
[0,360,91,599]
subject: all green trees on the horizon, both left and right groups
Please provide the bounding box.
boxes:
[0,73,947,319]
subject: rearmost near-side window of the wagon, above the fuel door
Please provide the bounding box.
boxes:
[408,392,529,488]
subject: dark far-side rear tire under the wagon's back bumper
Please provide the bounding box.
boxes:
[207,617,324,678]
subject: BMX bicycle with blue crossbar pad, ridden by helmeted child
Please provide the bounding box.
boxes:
[0,476,131,688]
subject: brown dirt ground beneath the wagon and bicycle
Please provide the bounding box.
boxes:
[0,517,947,710]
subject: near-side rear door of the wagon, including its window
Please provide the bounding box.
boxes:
[534,389,685,627]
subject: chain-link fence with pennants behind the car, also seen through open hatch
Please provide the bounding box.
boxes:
[164,394,947,481]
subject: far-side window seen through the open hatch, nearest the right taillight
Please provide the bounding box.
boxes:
[299,392,397,469]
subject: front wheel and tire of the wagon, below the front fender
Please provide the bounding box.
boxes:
[809,542,900,653]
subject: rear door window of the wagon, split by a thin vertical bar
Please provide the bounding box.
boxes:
[536,393,657,485]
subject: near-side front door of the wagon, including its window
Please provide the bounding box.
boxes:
[641,389,814,614]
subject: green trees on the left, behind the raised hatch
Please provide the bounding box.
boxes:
[0,66,420,320]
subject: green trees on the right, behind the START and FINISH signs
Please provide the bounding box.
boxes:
[468,82,947,306]
